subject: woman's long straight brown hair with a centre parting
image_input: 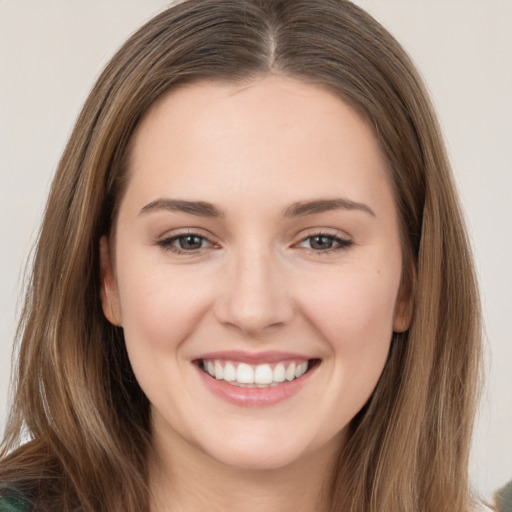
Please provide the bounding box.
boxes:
[0,0,481,512]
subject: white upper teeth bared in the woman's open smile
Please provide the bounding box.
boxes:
[196,359,320,388]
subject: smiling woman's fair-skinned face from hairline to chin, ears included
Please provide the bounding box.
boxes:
[101,77,409,468]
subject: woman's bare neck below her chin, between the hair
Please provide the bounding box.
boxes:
[149,430,339,512]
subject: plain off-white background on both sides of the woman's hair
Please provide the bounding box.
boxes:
[0,0,512,504]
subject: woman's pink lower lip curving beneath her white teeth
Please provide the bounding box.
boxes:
[196,365,319,407]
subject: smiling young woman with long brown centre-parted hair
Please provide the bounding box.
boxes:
[0,0,480,512]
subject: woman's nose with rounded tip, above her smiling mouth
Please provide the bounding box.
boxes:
[215,247,294,337]
